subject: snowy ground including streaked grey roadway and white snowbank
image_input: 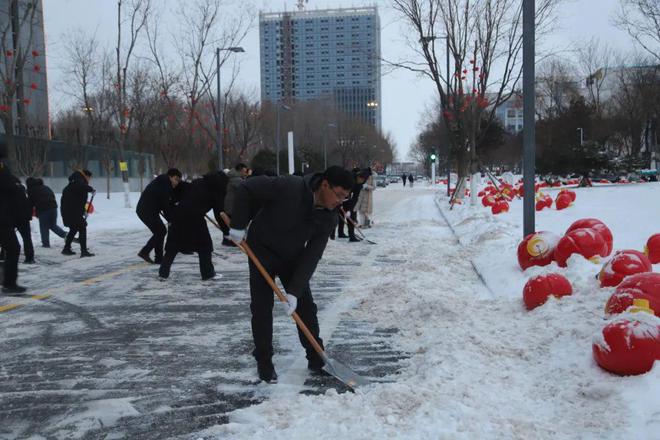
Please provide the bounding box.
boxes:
[0,185,660,440]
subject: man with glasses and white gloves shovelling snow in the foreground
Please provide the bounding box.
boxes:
[229,166,354,382]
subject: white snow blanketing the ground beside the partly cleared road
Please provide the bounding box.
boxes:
[5,183,660,440]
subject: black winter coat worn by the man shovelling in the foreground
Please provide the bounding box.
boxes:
[231,174,337,296]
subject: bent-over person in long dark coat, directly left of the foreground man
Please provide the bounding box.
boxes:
[158,171,229,281]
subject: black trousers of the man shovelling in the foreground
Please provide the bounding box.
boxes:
[250,245,323,363]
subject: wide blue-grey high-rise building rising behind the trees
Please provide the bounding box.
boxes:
[259,6,382,130]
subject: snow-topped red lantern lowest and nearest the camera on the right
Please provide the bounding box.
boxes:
[592,313,660,376]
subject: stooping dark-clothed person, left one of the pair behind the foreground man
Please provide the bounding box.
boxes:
[135,168,181,264]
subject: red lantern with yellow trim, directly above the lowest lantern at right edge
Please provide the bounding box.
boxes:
[605,272,660,317]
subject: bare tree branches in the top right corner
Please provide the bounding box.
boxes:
[615,0,660,61]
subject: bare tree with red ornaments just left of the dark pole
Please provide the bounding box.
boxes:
[388,0,561,198]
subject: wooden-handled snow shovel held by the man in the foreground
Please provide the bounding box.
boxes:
[218,212,369,390]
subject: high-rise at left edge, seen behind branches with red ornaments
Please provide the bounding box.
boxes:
[0,0,50,138]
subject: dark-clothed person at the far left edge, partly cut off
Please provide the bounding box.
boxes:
[0,143,26,295]
